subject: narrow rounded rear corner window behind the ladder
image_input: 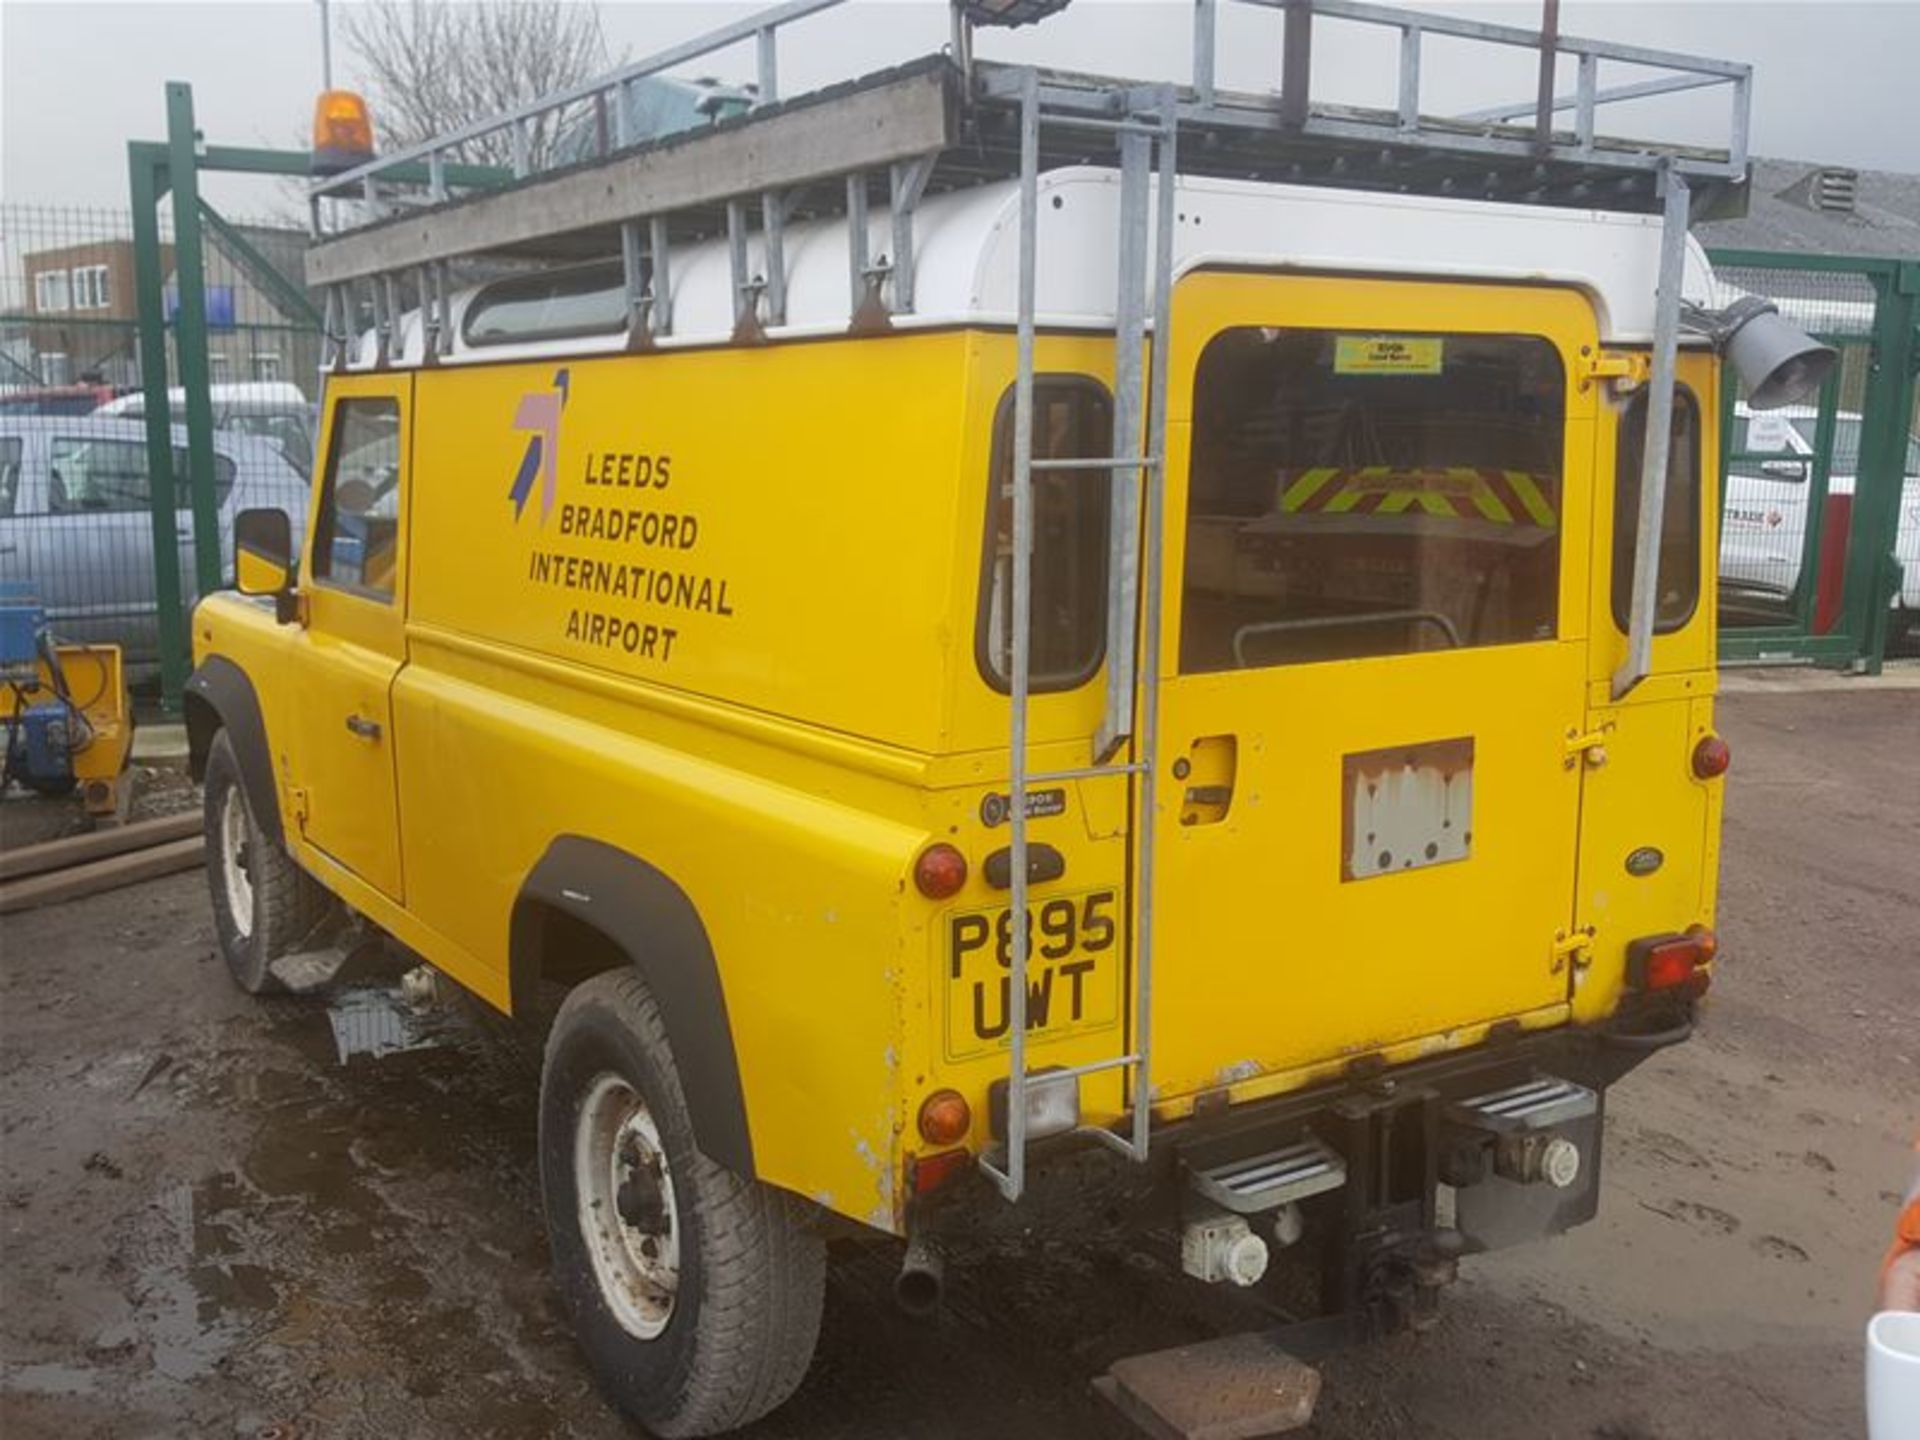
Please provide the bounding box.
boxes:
[975,374,1114,691]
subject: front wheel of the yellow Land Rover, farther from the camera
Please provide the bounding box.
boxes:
[204,730,338,995]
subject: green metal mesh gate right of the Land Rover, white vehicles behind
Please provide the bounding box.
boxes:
[1711,250,1920,672]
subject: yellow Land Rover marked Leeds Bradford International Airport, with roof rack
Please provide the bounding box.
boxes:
[188,0,1826,1436]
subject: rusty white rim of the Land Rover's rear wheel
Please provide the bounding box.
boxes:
[574,1073,680,1340]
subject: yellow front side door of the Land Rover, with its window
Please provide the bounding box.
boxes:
[294,374,413,900]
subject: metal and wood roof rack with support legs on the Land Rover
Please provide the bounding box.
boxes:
[307,0,1751,365]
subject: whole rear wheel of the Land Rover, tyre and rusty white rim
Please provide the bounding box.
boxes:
[540,970,826,1440]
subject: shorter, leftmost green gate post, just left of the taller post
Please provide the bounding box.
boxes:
[127,140,190,714]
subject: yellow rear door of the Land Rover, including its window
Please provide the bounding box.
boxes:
[1154,273,1597,1096]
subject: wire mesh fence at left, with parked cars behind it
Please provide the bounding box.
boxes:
[0,205,321,678]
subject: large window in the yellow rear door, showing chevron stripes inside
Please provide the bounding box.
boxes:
[1181,326,1567,674]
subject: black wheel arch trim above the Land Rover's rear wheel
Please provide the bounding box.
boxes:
[509,835,755,1179]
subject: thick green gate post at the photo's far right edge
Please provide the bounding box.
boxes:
[1843,261,1920,676]
